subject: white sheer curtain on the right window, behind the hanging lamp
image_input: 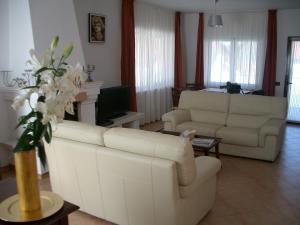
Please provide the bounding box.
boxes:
[204,12,267,89]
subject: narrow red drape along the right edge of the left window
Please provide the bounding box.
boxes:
[174,12,183,88]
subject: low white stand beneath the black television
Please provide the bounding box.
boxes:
[106,112,144,129]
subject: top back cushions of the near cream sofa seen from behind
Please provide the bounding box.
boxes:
[53,121,196,186]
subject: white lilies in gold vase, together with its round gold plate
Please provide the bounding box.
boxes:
[0,37,86,222]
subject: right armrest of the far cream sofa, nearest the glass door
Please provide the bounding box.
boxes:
[259,119,286,146]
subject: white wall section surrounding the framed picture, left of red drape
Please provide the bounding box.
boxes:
[74,0,121,87]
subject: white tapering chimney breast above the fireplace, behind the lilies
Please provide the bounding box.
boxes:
[29,0,85,65]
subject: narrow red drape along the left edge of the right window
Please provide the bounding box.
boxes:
[195,13,204,88]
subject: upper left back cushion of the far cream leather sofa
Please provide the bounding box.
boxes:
[178,91,230,113]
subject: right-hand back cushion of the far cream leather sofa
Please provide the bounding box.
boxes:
[226,94,287,128]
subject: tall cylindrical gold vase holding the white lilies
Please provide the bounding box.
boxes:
[14,149,42,219]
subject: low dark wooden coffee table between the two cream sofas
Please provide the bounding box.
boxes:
[159,130,222,159]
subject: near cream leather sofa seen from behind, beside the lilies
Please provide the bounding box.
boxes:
[46,121,221,225]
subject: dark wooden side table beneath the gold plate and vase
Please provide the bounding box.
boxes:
[0,178,79,225]
